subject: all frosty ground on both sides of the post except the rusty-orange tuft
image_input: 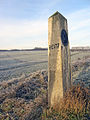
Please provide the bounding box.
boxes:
[0,51,90,120]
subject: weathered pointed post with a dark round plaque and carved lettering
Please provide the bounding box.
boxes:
[48,12,71,106]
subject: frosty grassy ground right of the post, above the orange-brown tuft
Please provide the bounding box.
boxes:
[71,51,90,88]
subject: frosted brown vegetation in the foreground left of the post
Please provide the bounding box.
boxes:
[0,71,47,120]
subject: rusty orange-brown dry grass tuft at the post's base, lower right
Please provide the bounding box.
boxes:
[42,85,90,120]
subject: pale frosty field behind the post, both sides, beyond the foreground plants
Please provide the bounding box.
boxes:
[0,50,90,86]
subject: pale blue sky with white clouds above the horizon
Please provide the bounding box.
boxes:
[0,0,90,49]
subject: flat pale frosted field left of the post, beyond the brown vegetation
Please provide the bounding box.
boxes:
[0,51,48,81]
